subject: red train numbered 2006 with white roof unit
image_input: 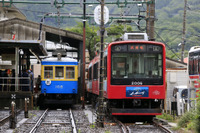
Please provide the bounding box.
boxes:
[87,33,166,116]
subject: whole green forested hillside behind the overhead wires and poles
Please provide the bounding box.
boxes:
[15,0,200,59]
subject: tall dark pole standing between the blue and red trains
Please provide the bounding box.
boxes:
[97,0,105,127]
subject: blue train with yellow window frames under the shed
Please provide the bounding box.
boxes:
[39,57,78,108]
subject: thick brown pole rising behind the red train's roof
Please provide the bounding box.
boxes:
[146,0,155,41]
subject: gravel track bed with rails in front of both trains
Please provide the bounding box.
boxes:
[0,108,172,133]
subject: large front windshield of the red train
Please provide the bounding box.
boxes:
[111,52,163,85]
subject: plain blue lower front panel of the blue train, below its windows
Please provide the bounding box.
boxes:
[41,81,78,94]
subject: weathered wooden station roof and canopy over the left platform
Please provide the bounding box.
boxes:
[0,18,83,56]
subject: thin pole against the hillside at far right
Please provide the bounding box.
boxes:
[181,0,187,62]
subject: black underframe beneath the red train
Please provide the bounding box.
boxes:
[88,93,164,116]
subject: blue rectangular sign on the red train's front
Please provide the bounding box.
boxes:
[126,87,149,97]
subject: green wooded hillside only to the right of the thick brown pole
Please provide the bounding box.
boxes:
[155,0,200,59]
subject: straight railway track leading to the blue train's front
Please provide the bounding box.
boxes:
[26,109,77,133]
